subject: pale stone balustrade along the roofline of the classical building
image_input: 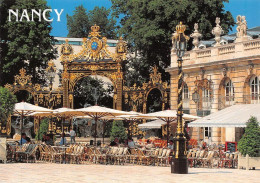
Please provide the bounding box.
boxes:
[170,38,260,71]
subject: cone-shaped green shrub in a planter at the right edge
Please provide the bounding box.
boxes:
[238,117,260,157]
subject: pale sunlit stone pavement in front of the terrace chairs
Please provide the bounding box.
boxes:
[0,163,260,183]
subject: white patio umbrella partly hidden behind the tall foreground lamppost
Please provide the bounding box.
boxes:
[140,110,200,144]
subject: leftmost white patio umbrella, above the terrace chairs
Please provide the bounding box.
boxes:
[13,102,52,144]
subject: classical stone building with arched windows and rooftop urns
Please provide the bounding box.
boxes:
[167,16,260,144]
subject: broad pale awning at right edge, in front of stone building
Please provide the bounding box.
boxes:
[188,104,260,128]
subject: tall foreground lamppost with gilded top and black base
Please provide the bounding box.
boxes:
[171,22,189,174]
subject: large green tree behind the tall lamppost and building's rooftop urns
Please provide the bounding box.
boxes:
[112,0,235,83]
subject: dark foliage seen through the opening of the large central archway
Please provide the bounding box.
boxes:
[74,77,113,108]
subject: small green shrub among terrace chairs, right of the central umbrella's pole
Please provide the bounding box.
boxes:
[110,121,127,142]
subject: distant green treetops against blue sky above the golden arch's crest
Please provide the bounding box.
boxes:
[67,5,116,38]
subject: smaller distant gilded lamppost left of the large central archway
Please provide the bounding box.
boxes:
[46,60,56,138]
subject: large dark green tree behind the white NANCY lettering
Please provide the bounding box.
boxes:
[3,0,56,83]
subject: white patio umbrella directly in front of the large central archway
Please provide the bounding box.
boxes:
[76,105,128,144]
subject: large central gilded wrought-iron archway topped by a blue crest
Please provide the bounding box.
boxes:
[61,25,127,109]
